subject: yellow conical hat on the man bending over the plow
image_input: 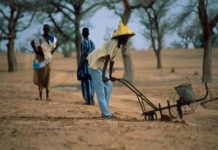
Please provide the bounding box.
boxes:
[112,21,135,38]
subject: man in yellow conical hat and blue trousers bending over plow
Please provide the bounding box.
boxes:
[87,22,135,119]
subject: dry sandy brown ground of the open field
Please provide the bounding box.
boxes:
[0,49,218,150]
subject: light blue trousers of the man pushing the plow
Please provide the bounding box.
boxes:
[89,67,112,117]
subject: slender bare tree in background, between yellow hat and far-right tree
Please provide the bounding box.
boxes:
[140,0,173,69]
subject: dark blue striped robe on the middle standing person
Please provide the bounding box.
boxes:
[79,39,95,104]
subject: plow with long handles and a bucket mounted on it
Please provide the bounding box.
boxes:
[116,78,217,120]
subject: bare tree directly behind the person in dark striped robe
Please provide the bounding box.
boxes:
[46,0,104,63]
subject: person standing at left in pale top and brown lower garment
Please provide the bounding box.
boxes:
[31,24,57,100]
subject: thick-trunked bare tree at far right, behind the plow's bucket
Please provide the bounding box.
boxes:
[175,0,218,84]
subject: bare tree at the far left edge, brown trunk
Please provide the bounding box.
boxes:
[0,0,34,72]
